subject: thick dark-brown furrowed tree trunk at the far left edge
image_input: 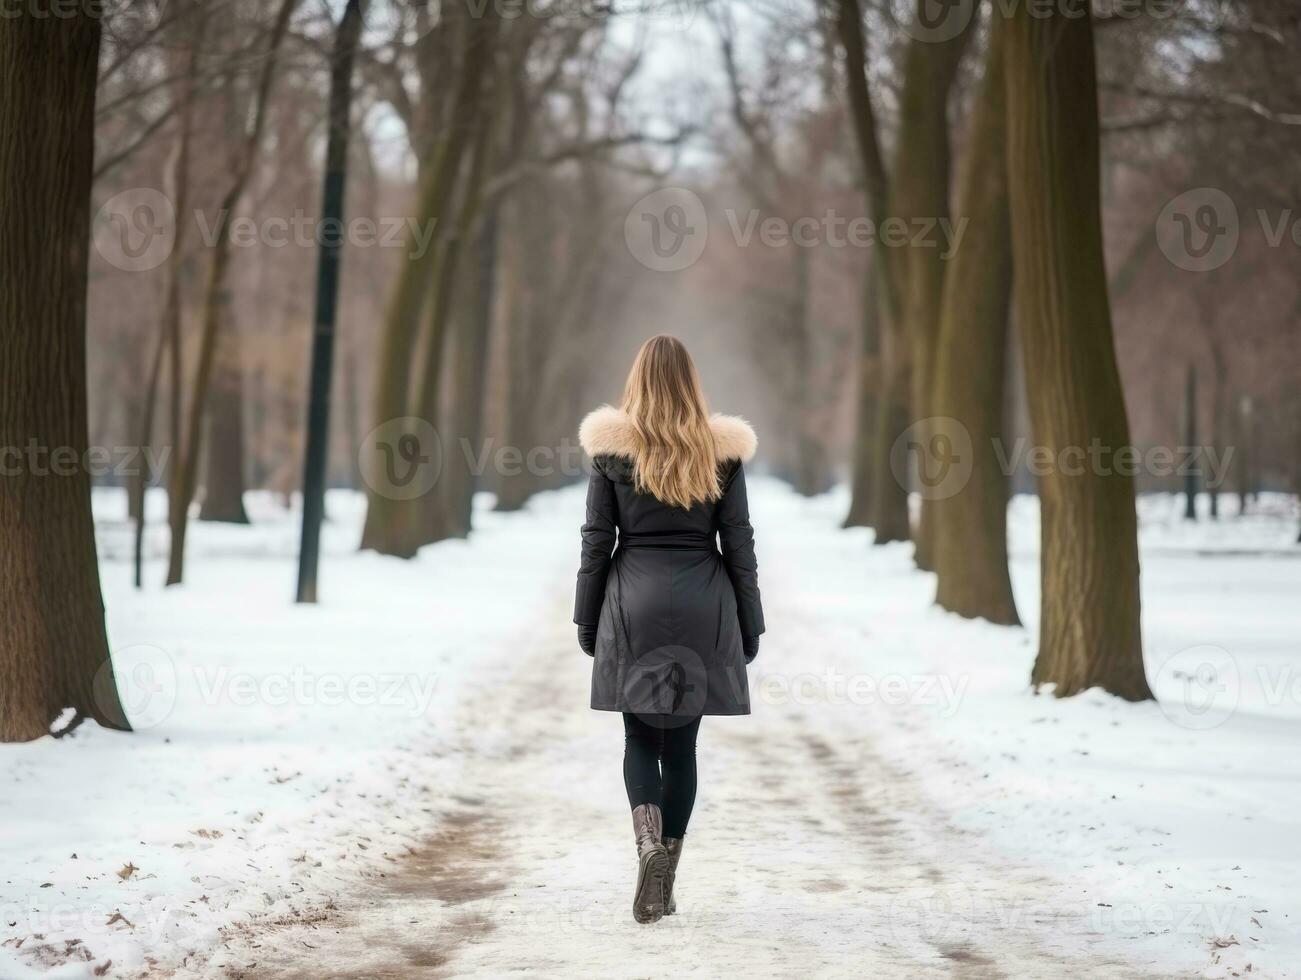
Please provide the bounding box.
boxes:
[0,17,129,742]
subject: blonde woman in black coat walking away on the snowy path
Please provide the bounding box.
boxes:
[574,336,764,923]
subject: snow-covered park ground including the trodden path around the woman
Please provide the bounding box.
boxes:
[0,479,1301,980]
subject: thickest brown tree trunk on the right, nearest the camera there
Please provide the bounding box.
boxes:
[1004,0,1151,700]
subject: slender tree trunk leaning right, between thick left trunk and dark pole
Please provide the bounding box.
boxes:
[167,0,297,586]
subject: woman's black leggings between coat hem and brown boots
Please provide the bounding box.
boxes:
[623,712,700,837]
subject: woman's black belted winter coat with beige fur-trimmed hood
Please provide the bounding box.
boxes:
[574,406,764,717]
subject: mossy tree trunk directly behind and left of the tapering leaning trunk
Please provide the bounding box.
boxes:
[892,0,977,569]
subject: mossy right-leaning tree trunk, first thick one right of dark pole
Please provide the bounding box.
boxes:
[362,5,498,558]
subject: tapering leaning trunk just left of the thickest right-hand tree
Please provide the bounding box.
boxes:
[932,21,1020,623]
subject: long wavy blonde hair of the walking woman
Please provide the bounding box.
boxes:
[621,334,722,510]
